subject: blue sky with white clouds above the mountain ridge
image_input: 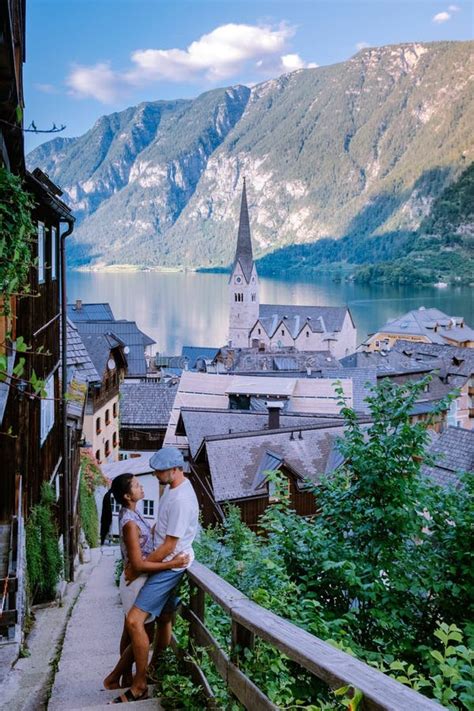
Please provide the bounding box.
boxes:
[25,0,474,150]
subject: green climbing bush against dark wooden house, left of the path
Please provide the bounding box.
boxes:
[25,483,63,602]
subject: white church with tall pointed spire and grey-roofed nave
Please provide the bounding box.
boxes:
[229,179,357,358]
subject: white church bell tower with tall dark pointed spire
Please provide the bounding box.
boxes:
[229,178,260,348]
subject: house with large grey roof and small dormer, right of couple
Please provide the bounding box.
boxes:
[190,421,344,528]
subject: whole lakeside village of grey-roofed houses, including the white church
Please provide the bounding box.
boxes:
[0,2,474,708]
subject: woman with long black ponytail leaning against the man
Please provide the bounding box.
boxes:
[101,474,189,701]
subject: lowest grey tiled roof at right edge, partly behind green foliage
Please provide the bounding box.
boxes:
[422,427,474,486]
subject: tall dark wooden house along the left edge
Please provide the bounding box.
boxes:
[0,0,77,644]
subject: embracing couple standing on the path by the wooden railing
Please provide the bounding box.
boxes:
[102,447,199,703]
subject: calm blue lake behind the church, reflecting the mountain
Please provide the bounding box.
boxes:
[67,272,474,355]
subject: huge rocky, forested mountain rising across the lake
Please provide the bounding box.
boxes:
[28,42,474,267]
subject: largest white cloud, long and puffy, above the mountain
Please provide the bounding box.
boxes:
[67,23,316,103]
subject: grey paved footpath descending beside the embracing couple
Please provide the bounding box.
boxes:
[48,547,161,711]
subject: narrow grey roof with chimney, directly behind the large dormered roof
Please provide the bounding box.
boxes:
[178,407,344,457]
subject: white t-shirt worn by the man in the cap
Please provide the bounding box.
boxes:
[155,479,199,570]
